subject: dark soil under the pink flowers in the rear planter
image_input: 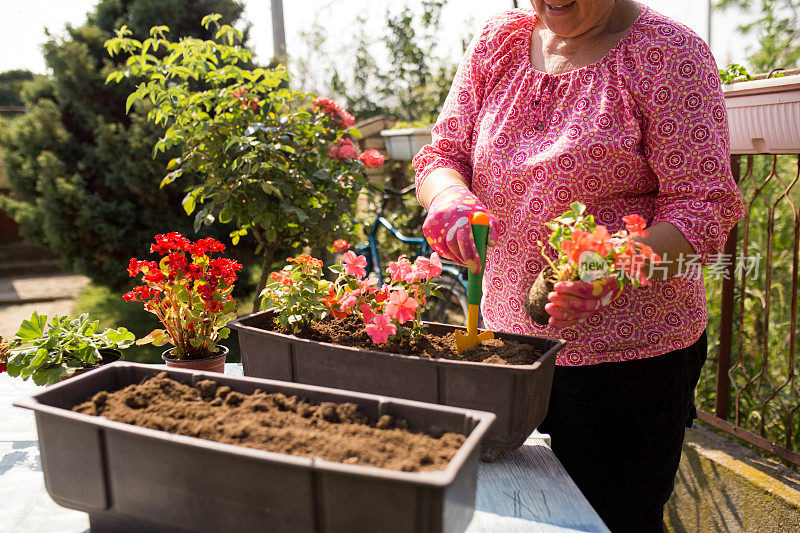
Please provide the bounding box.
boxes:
[272,315,542,365]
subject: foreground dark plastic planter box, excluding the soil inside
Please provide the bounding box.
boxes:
[15,363,494,533]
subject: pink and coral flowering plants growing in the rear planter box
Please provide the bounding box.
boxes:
[263,246,442,344]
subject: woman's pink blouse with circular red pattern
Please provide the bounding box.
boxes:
[413,6,743,365]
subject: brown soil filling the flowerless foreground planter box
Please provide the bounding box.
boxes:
[72,372,466,472]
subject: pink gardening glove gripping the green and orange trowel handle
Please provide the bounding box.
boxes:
[422,185,497,274]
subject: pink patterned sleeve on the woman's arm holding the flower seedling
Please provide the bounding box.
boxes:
[632,34,744,264]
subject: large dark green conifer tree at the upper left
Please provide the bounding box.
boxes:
[0,0,247,287]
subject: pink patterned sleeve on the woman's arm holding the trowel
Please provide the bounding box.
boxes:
[412,20,489,190]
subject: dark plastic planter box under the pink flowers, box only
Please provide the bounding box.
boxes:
[228,311,564,461]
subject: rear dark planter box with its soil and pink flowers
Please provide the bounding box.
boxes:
[225,245,563,460]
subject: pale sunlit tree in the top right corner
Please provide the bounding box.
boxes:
[716,0,800,72]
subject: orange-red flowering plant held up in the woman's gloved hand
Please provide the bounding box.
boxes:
[545,202,661,288]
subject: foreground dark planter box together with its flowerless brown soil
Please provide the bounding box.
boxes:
[15,363,493,533]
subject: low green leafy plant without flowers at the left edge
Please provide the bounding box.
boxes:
[0,311,136,385]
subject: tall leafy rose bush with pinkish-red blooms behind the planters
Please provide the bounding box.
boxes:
[106,15,383,306]
